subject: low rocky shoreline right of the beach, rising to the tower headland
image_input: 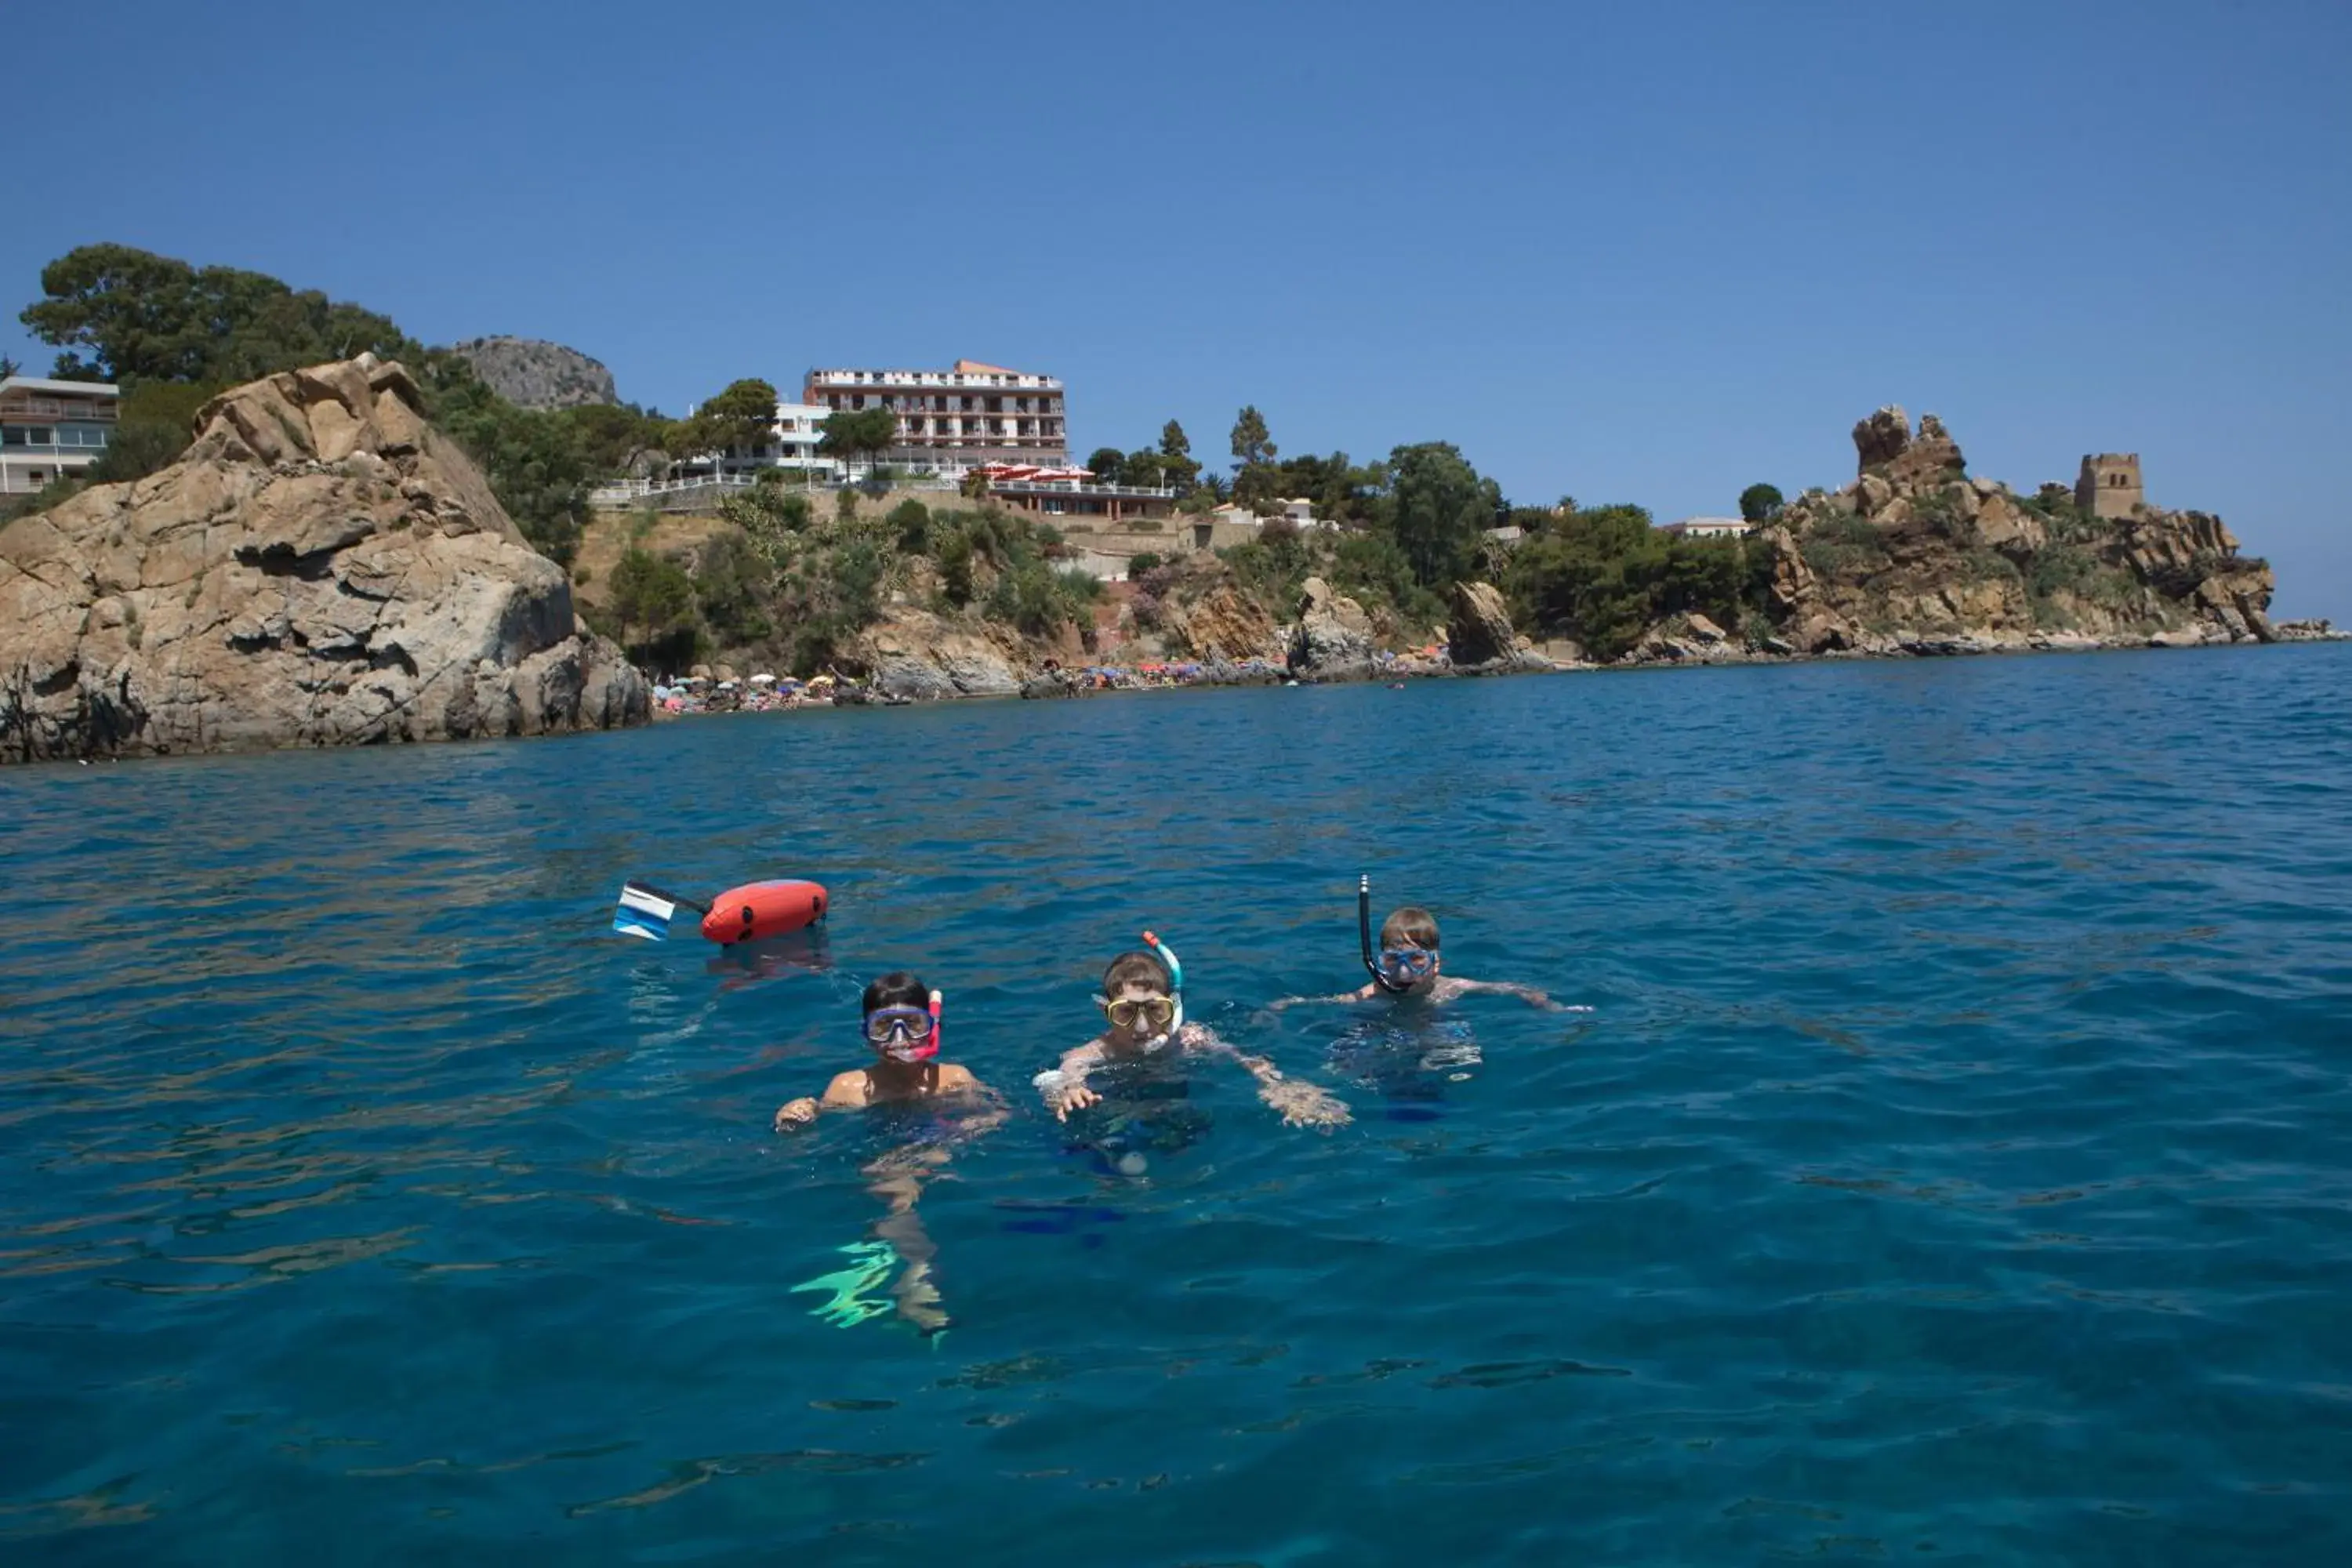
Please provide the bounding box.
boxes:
[734,407,2314,701]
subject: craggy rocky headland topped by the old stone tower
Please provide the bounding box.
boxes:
[1752,407,2277,654]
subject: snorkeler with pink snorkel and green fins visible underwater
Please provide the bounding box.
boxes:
[776,973,1004,1335]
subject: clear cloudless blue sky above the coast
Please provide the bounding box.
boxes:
[18,0,2352,621]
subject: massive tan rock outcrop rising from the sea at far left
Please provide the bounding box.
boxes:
[0,355,649,762]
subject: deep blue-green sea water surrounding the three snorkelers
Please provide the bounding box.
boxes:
[0,647,2352,1568]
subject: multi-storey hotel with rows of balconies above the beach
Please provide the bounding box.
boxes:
[800,360,1070,475]
